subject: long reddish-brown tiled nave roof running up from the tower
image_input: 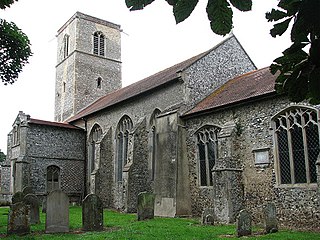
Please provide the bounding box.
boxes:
[67,35,235,122]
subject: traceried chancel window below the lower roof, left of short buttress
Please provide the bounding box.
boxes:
[196,126,220,186]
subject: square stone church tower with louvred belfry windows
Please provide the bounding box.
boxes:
[54,12,122,122]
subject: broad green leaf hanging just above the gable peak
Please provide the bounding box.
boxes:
[207,0,233,36]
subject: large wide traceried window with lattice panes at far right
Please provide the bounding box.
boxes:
[273,107,320,185]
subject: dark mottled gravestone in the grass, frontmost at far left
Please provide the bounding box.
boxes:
[7,202,30,235]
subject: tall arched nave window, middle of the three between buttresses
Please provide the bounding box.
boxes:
[116,116,133,181]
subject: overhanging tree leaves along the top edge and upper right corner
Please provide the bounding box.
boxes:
[125,0,320,104]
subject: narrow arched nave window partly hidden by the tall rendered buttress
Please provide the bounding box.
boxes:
[149,108,161,180]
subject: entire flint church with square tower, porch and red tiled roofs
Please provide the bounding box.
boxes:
[1,12,320,229]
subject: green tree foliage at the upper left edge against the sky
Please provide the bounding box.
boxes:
[0,0,32,85]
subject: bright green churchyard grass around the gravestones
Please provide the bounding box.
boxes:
[0,207,320,240]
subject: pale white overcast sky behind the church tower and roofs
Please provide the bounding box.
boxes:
[0,0,290,153]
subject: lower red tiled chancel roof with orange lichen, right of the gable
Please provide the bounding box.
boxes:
[183,67,277,116]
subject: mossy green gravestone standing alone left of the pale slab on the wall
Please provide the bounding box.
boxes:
[137,192,155,221]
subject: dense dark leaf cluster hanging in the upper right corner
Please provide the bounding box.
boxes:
[266,0,320,104]
